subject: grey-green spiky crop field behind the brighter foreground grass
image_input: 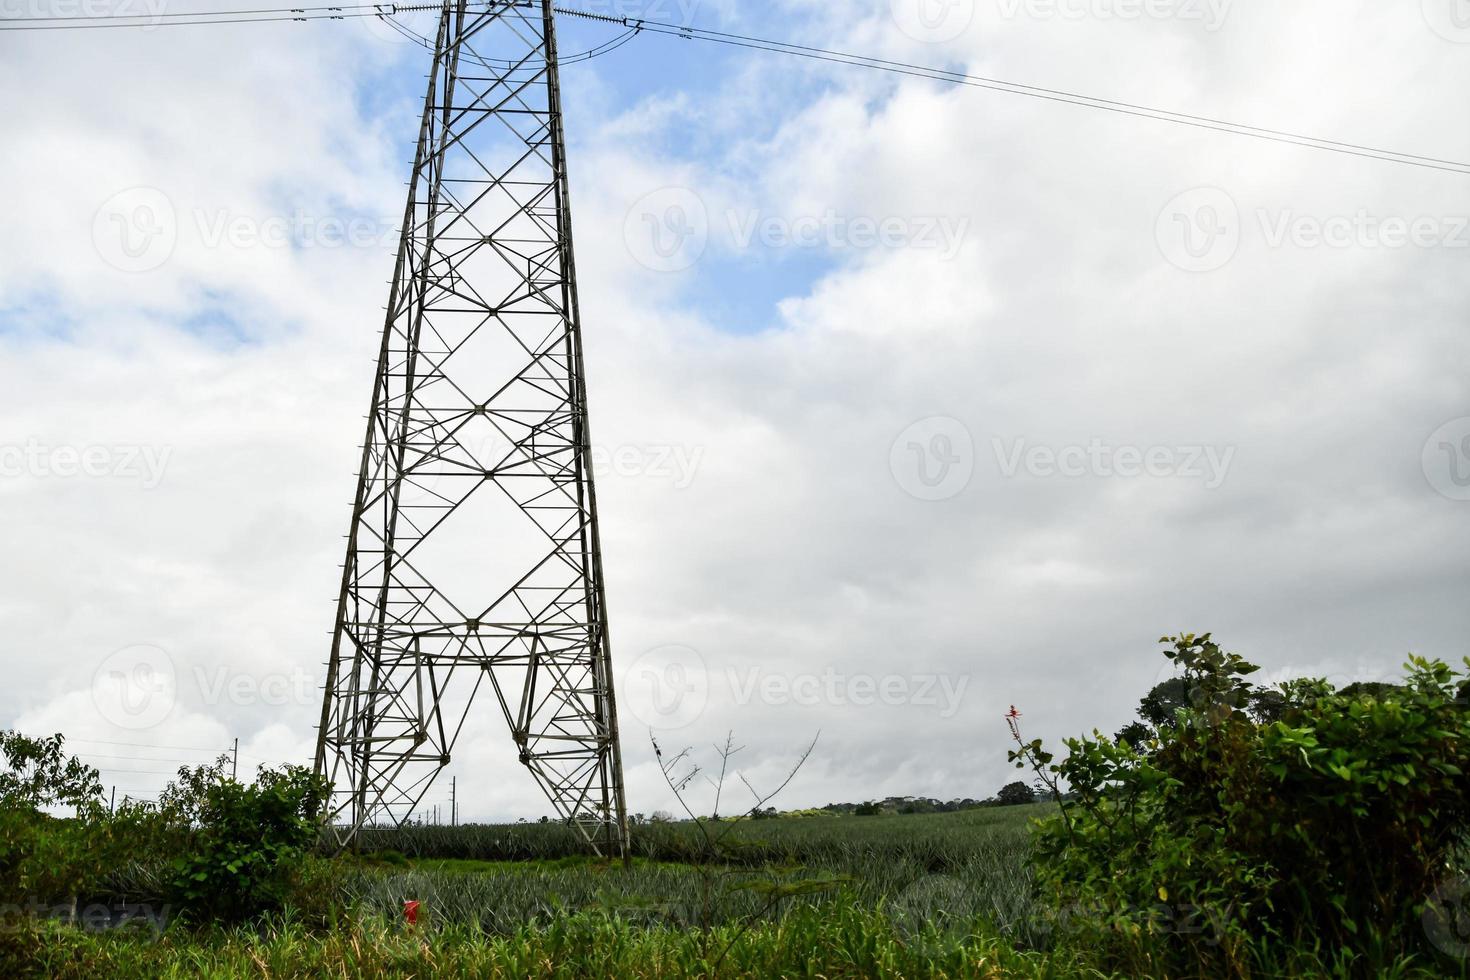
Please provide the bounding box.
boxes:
[344,807,1050,940]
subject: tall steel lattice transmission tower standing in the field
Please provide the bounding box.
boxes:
[316,0,628,854]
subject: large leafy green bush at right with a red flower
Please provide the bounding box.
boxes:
[1011,633,1470,974]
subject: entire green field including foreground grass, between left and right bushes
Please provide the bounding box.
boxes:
[14,807,1076,977]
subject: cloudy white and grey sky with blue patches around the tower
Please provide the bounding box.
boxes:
[0,0,1470,818]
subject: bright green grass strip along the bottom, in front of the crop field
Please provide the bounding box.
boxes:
[16,902,1101,980]
